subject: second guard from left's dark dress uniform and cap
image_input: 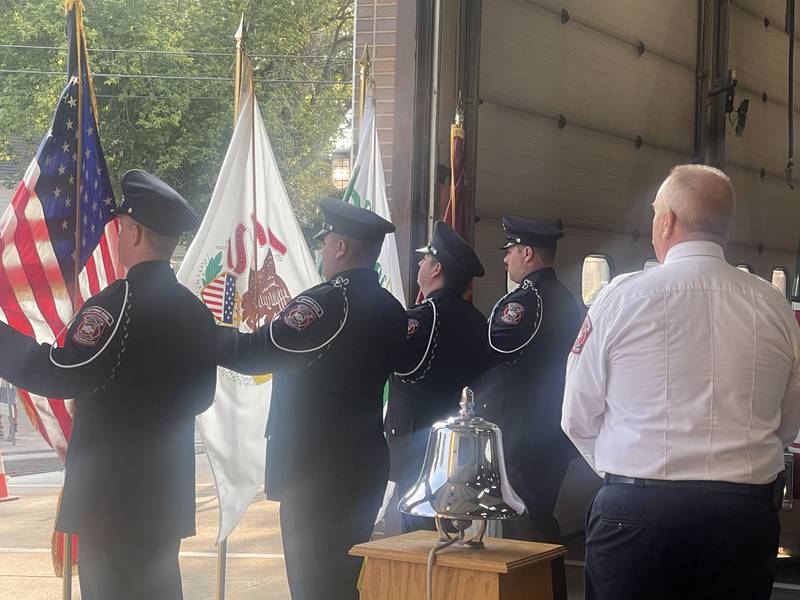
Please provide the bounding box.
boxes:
[219,200,406,600]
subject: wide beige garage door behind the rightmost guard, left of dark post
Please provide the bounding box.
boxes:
[475,0,697,310]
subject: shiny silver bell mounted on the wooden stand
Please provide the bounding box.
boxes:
[400,387,525,548]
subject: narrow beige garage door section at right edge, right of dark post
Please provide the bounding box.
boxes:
[725,0,800,279]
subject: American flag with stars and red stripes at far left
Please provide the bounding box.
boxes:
[0,0,122,461]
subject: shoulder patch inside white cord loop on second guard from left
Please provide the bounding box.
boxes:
[269,280,349,353]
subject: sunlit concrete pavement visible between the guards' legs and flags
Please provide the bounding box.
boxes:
[0,454,289,600]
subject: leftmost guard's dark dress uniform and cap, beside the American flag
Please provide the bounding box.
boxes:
[0,171,216,600]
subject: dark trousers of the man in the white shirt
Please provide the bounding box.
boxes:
[586,483,780,600]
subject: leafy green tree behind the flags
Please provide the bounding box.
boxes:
[0,0,353,227]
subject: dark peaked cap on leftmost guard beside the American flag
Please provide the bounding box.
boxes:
[113,169,200,237]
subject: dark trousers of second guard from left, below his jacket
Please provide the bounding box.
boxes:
[280,474,386,600]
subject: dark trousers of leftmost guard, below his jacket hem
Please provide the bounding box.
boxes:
[78,535,183,600]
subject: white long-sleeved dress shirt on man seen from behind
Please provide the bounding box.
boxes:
[561,241,800,484]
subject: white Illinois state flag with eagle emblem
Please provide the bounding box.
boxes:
[178,65,319,542]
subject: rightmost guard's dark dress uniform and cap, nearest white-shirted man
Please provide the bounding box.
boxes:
[477,217,581,543]
